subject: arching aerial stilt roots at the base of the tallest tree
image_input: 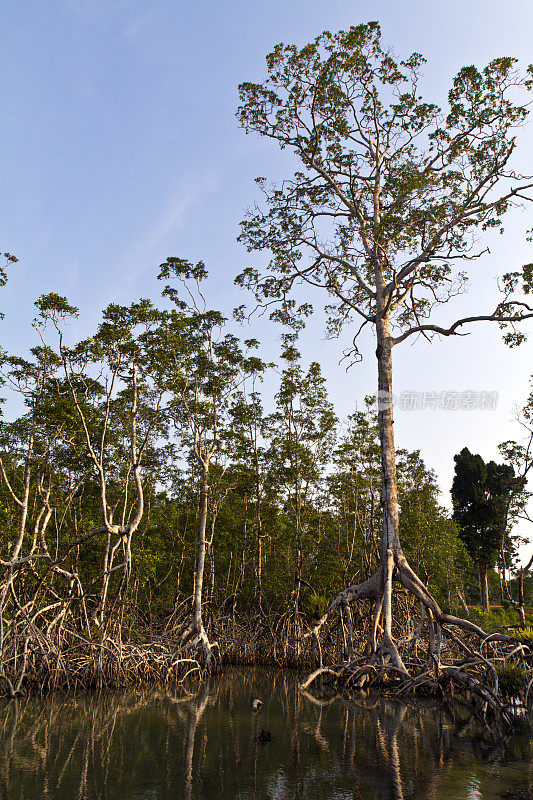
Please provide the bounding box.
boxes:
[300,550,533,723]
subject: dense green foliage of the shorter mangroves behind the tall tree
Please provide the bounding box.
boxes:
[0,259,516,636]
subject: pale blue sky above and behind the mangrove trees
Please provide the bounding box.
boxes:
[0,0,533,544]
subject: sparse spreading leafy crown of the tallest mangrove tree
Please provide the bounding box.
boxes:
[237,22,532,357]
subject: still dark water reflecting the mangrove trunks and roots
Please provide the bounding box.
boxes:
[0,670,533,800]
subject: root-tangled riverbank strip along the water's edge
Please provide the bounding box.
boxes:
[2,612,533,725]
